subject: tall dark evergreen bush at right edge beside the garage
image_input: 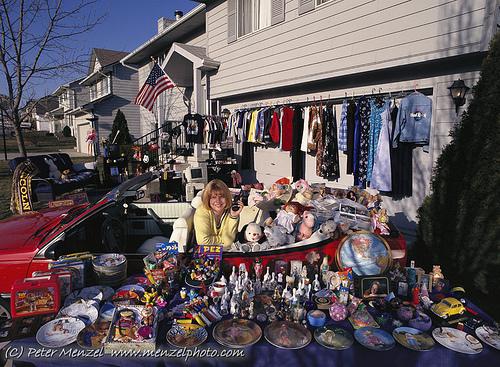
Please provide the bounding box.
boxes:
[416,33,500,319]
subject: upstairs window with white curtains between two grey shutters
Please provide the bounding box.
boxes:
[237,0,271,37]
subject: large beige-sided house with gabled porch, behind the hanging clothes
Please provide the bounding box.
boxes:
[122,0,499,242]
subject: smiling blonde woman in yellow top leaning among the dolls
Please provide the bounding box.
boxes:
[194,179,243,251]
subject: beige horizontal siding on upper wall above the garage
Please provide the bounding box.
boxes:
[207,0,492,98]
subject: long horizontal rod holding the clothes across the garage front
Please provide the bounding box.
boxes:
[235,88,433,111]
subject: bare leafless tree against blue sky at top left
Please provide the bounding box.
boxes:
[0,0,104,156]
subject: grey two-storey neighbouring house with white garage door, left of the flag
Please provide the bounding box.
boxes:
[68,48,140,154]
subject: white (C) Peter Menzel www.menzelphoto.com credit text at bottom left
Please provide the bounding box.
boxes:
[5,346,245,361]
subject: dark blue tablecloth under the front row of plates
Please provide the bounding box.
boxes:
[2,302,500,367]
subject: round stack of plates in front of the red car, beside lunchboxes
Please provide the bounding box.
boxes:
[92,254,127,287]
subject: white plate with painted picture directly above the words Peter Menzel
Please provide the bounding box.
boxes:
[36,317,85,348]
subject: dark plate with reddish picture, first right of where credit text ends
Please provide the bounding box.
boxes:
[264,321,312,349]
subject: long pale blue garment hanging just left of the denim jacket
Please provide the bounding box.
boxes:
[370,101,392,191]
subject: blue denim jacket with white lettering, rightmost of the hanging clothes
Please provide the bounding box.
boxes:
[392,92,432,152]
